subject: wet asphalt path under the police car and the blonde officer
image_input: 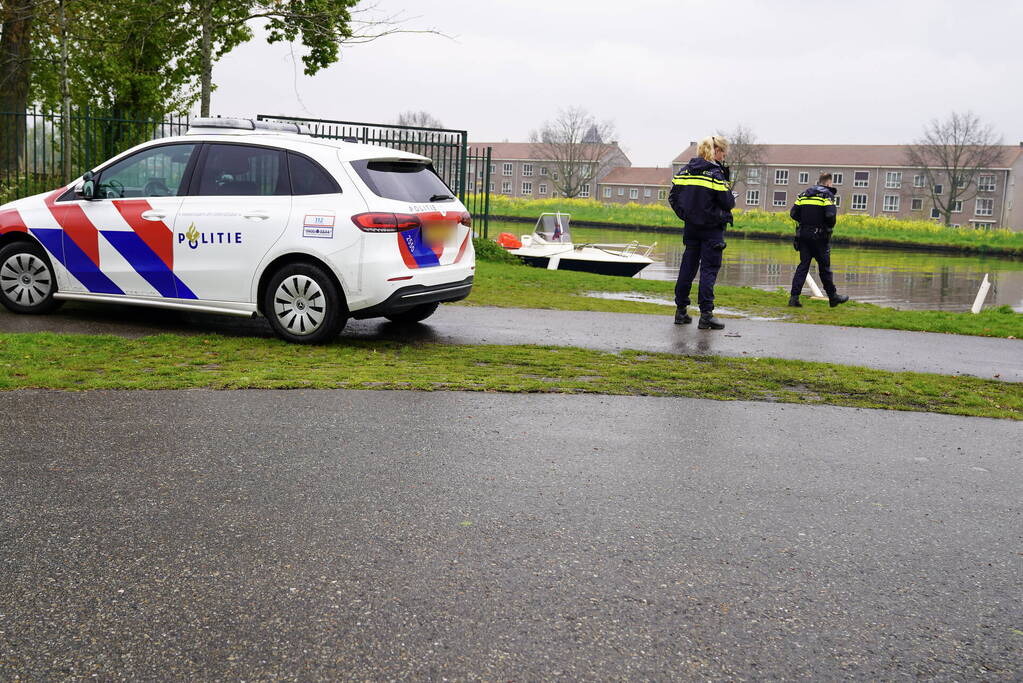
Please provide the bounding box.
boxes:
[0,303,1023,382]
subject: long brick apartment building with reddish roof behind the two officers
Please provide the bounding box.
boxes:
[672,142,1023,231]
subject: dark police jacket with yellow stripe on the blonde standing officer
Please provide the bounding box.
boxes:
[668,156,736,231]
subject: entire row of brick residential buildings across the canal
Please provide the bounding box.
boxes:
[470,142,1023,232]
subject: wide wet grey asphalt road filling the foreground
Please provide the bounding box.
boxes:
[0,391,1023,680]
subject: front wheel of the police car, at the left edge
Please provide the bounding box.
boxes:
[0,242,63,313]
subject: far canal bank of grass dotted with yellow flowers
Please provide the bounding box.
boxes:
[476,194,1023,258]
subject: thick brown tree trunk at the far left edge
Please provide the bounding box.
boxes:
[0,0,36,173]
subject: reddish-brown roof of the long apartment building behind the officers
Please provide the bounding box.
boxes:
[673,144,1023,169]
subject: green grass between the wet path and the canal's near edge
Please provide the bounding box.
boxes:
[462,254,1023,338]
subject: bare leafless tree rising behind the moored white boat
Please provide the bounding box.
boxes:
[529,106,615,197]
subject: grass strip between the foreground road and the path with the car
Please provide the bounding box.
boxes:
[0,332,1023,420]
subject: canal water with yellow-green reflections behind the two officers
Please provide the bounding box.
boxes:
[490,222,1023,313]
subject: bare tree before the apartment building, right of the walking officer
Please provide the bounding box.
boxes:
[905,111,1002,225]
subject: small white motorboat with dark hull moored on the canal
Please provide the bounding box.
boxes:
[497,213,657,277]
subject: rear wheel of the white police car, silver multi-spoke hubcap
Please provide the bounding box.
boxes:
[263,264,348,344]
